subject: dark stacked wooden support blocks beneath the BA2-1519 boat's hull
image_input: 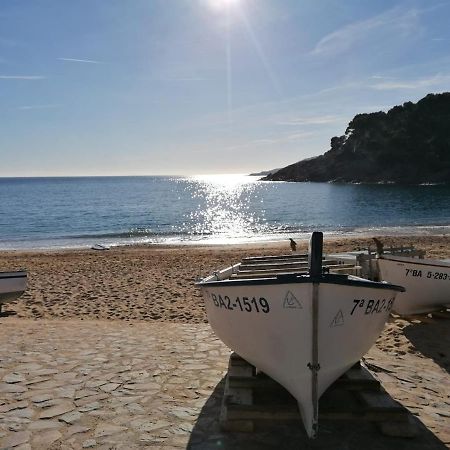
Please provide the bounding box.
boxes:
[220,353,416,437]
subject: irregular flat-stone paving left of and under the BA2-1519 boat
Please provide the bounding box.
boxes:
[0,318,445,450]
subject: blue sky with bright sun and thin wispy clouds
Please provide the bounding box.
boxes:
[0,0,450,177]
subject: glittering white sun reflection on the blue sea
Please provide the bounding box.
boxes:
[184,174,266,238]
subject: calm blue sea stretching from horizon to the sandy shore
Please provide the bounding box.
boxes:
[0,175,450,249]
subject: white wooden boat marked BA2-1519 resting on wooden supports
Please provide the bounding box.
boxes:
[197,233,403,437]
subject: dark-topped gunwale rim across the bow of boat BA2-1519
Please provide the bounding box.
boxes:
[195,273,405,292]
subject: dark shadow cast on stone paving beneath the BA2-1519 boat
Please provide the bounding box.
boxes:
[187,379,447,450]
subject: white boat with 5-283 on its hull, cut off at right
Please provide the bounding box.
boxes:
[377,253,450,316]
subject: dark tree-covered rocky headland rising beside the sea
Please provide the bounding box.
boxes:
[264,92,450,184]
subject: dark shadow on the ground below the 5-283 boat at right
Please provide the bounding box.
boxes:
[403,319,450,373]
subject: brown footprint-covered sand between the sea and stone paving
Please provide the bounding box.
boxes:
[0,235,450,323]
